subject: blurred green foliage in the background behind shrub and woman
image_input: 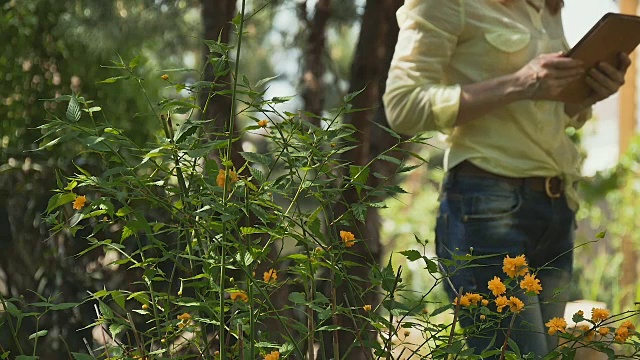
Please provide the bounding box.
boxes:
[0,0,640,359]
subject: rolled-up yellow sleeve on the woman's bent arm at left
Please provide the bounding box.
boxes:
[383,0,464,135]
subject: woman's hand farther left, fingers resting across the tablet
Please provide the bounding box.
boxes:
[514,52,584,100]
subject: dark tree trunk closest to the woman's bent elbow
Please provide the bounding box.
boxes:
[321,0,404,360]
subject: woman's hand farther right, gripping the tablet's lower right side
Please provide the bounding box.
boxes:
[586,53,631,104]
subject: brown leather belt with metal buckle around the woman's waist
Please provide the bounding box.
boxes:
[449,160,564,199]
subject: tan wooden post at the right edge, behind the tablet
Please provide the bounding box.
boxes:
[618,0,638,310]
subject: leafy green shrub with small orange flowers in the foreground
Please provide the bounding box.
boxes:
[0,3,638,360]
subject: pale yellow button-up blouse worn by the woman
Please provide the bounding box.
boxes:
[383,0,590,209]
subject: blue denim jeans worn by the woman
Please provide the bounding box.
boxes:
[436,171,575,359]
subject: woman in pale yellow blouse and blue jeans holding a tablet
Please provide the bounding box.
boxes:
[384,0,630,356]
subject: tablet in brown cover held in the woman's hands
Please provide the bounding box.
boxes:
[558,13,640,103]
